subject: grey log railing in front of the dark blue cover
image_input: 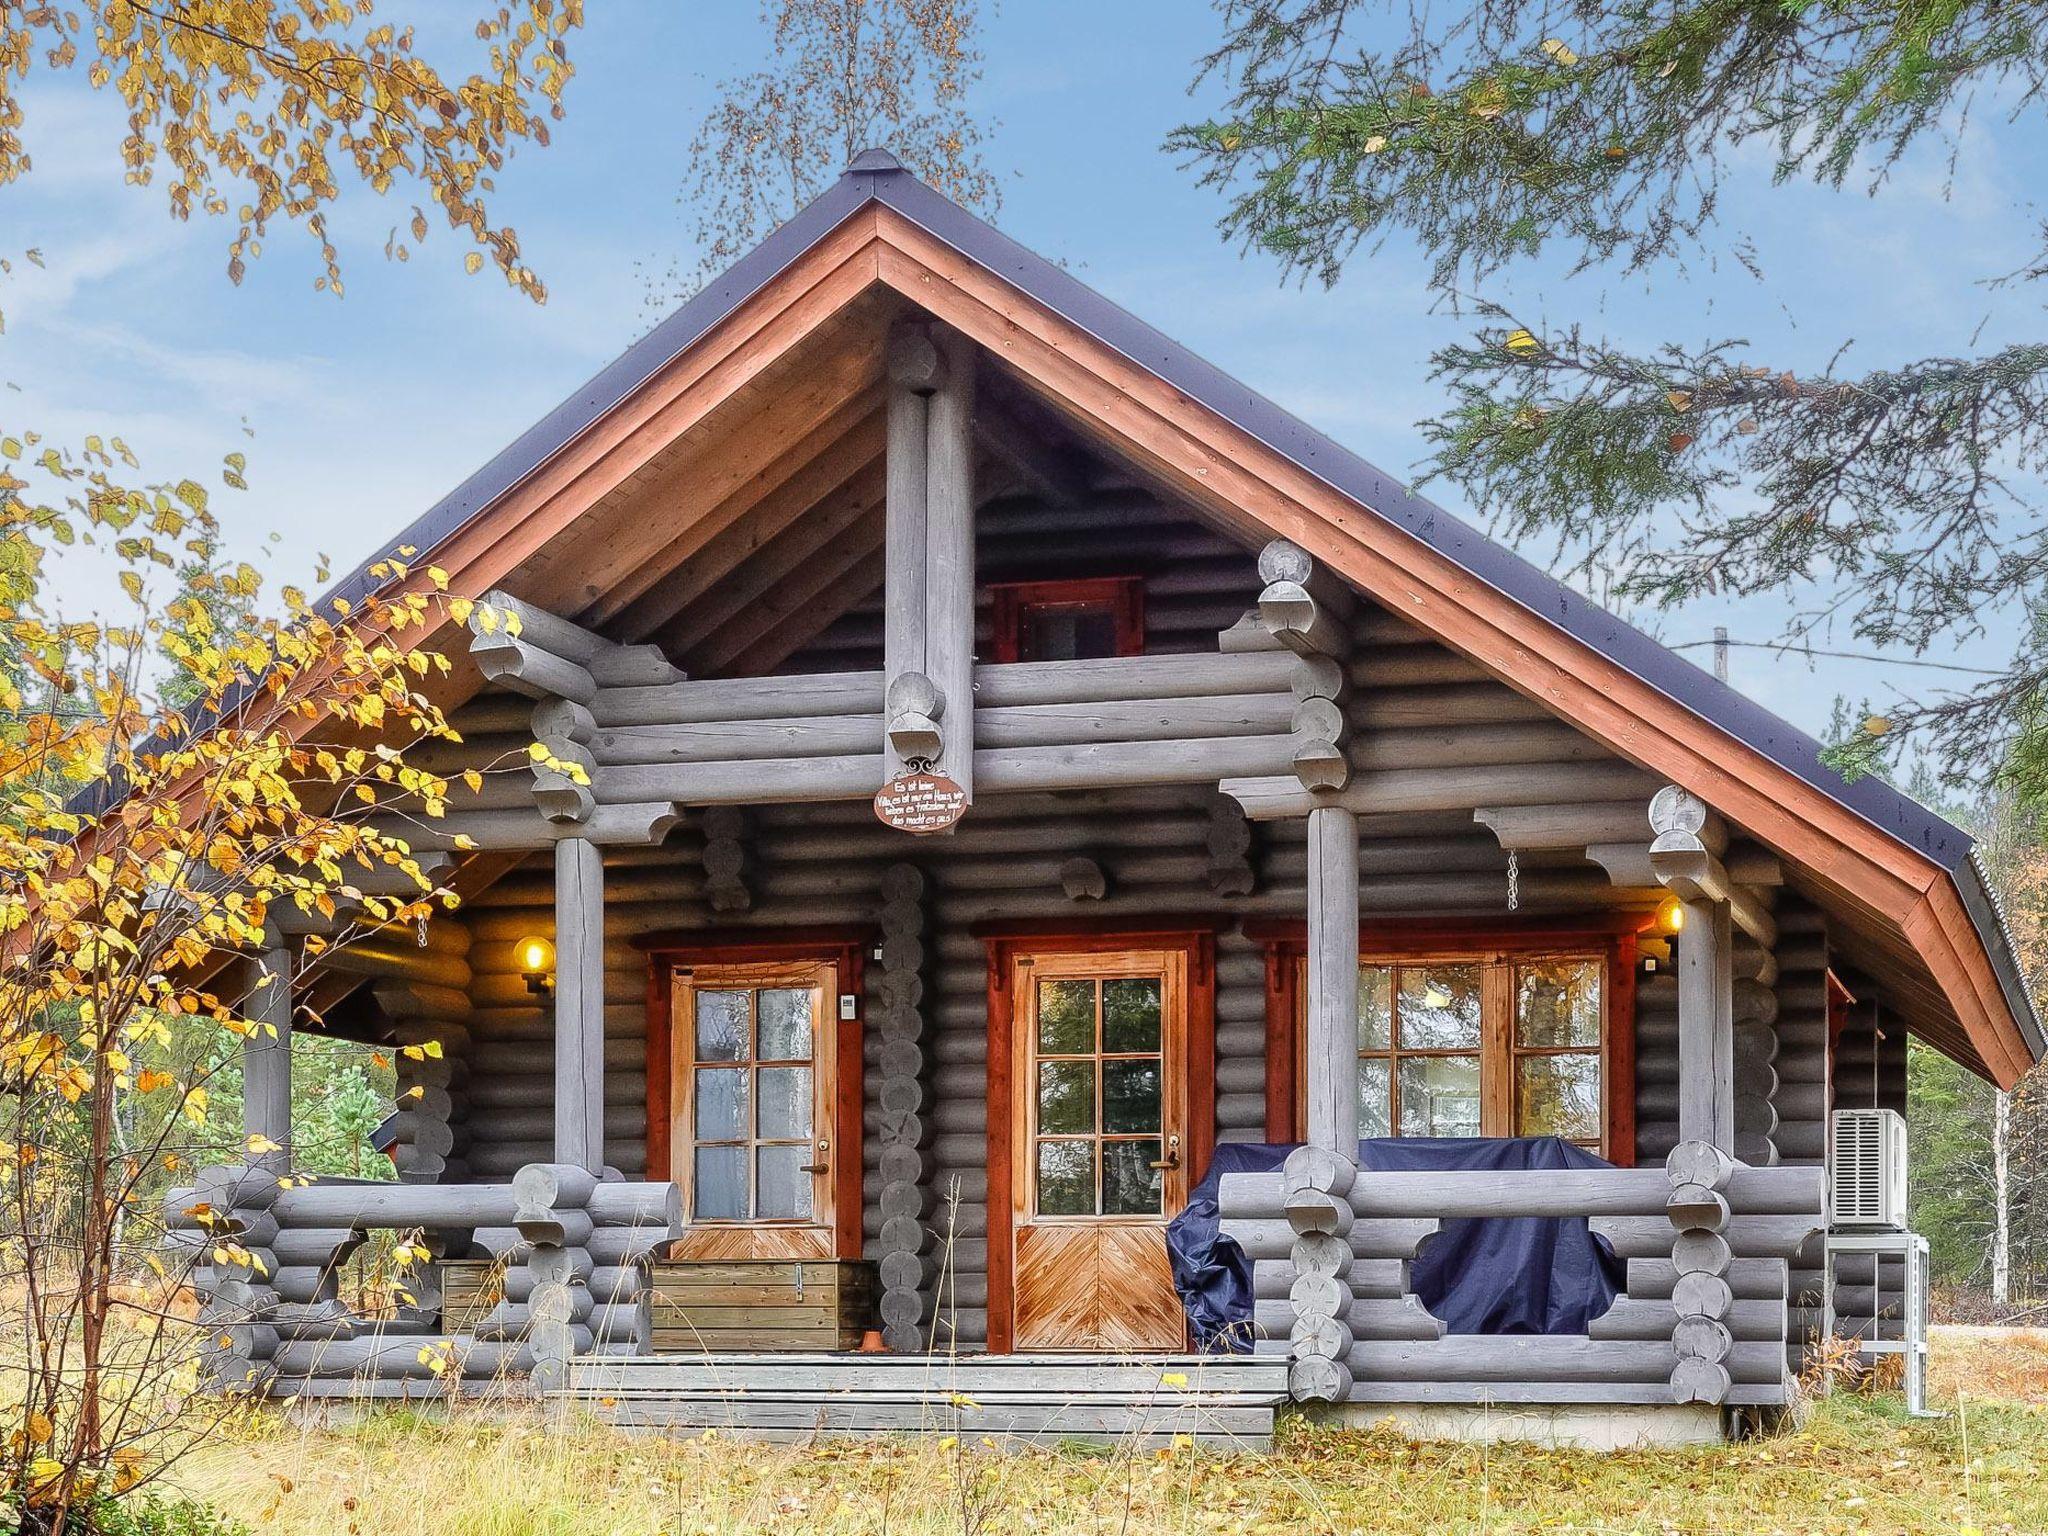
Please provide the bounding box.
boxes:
[1219,1143,1825,1407]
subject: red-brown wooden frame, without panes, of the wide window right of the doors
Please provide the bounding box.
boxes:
[1245,915,1653,1167]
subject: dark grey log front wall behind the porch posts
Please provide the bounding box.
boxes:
[448,581,1675,1348]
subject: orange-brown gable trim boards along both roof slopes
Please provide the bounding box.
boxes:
[299,189,2032,1085]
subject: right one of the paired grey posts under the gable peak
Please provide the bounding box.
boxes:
[924,332,975,801]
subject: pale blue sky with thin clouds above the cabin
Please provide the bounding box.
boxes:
[0,0,2044,745]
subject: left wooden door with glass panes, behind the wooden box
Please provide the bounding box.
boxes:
[670,961,839,1260]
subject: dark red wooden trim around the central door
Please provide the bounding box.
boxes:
[973,918,1217,1354]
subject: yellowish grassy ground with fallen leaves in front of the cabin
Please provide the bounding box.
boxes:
[167,1329,2048,1536]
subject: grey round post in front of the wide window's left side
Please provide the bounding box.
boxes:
[1305,805,1358,1161]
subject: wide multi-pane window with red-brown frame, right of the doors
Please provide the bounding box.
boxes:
[1268,932,1634,1163]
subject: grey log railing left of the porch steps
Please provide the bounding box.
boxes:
[166,1163,682,1397]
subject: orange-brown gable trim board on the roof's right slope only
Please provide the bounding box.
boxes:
[874,207,2032,1083]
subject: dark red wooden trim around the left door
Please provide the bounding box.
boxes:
[633,928,877,1260]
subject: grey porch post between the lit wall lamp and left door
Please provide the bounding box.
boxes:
[555,838,604,1174]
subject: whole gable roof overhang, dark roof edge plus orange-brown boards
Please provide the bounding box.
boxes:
[216,156,2044,1085]
